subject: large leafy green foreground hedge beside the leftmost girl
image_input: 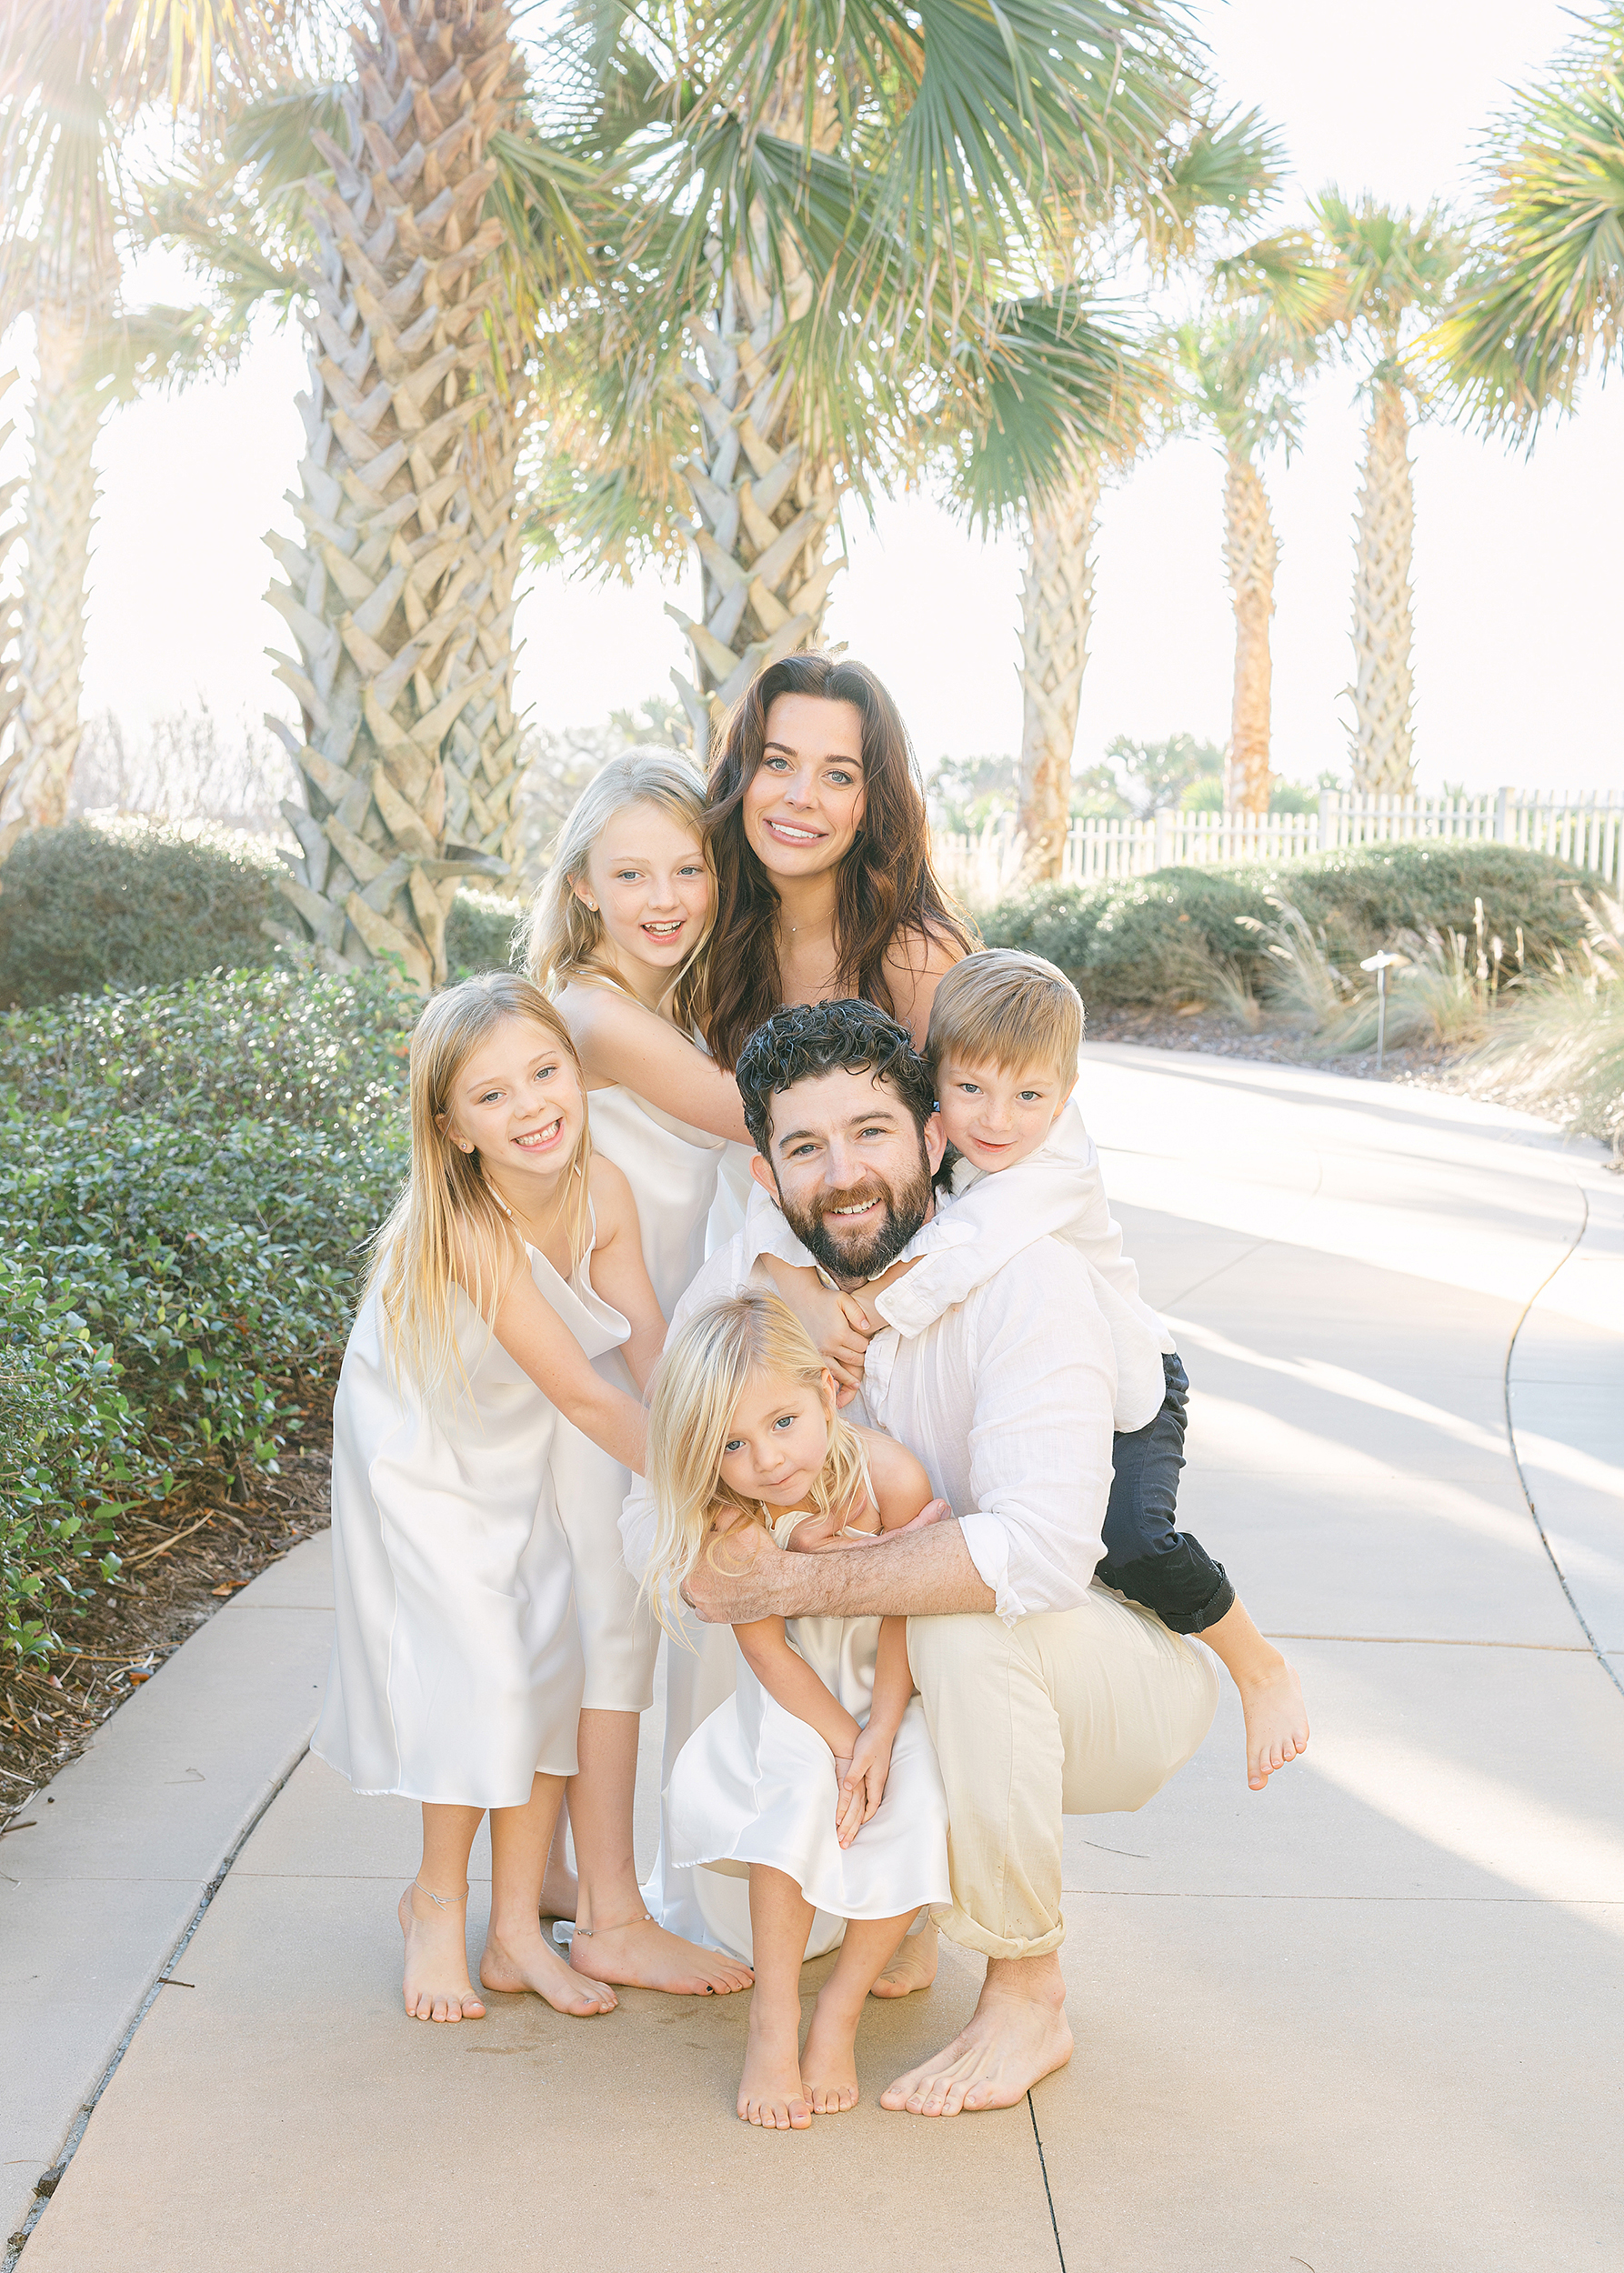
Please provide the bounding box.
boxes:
[0,968,416,1653]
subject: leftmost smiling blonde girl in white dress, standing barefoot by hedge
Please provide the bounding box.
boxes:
[312,973,664,2021]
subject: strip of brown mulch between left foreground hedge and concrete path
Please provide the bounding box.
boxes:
[0,1418,332,1835]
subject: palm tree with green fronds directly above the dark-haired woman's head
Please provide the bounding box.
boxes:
[564,0,1197,748]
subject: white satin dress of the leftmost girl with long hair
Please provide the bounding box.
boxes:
[312,1230,630,1807]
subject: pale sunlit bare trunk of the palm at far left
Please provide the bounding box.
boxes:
[14,302,112,827]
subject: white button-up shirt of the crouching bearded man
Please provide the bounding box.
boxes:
[621,1187,1117,1626]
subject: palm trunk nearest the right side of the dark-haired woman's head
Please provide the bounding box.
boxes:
[1017,459,1098,882]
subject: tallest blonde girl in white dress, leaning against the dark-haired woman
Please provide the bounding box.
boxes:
[526,748,753,1996]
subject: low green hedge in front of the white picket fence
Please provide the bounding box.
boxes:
[980,844,1585,1005]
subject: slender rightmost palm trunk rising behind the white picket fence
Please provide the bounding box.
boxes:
[1348,385,1415,796]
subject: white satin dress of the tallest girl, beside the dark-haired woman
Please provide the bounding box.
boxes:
[559,1086,726,1712]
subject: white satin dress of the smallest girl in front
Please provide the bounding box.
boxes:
[667,1512,951,1964]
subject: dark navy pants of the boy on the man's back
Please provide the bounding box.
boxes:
[1094,1355,1235,1635]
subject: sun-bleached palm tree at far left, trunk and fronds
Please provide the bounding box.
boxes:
[0,0,274,826]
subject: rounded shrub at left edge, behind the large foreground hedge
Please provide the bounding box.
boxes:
[0,821,285,1005]
